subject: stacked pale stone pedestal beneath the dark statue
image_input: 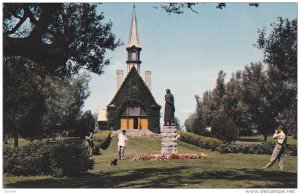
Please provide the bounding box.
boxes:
[160,125,178,154]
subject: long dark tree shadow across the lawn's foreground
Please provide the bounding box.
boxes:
[4,167,297,188]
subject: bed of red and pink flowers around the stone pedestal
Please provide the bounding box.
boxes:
[133,153,207,160]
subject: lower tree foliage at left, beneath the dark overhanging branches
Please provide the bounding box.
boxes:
[3,57,89,146]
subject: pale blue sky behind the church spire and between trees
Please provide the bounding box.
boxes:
[84,3,297,129]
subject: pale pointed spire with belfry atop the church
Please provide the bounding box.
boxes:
[126,6,142,72]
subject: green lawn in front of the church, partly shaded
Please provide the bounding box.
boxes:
[3,137,297,188]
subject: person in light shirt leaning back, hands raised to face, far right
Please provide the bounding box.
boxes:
[265,126,286,171]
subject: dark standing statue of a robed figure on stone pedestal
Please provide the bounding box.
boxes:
[164,89,175,125]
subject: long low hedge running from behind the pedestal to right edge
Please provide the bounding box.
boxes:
[180,132,297,156]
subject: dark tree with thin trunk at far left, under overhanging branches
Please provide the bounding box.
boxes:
[3,57,46,147]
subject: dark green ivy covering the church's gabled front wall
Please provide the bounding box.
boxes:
[107,68,161,133]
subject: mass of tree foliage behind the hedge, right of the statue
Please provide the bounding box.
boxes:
[185,17,297,141]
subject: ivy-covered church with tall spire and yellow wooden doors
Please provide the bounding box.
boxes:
[98,8,161,133]
